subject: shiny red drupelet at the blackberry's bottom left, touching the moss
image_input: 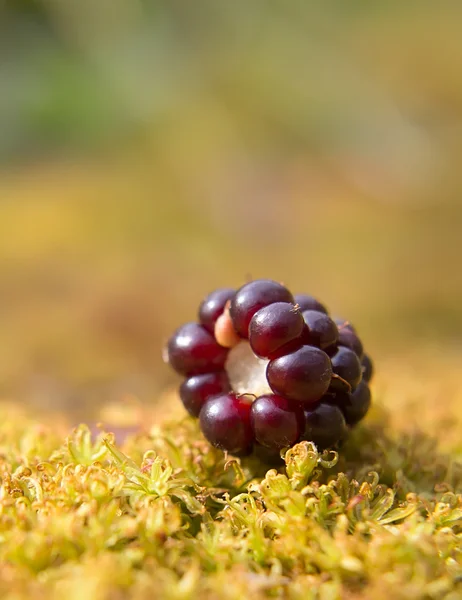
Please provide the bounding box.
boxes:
[199,393,254,456]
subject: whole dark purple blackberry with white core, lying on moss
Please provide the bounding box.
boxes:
[165,279,373,463]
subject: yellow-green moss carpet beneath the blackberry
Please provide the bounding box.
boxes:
[0,398,462,600]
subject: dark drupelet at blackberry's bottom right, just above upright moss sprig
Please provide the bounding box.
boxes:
[302,402,347,450]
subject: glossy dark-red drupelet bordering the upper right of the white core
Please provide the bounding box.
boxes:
[249,302,304,358]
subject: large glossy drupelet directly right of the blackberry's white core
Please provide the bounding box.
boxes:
[266,346,332,404]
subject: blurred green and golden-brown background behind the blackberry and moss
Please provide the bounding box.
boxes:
[0,0,462,419]
